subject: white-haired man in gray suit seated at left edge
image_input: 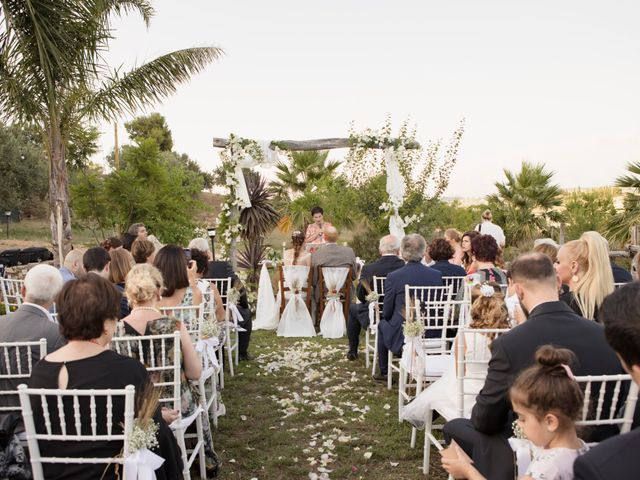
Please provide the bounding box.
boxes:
[0,264,64,433]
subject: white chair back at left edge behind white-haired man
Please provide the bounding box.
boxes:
[0,338,47,412]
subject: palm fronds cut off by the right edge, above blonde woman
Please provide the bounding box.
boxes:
[605,162,640,243]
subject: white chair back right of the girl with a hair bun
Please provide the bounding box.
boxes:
[576,375,638,433]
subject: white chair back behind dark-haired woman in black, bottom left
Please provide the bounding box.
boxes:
[18,384,135,480]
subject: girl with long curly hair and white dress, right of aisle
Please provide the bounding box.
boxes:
[402,283,510,429]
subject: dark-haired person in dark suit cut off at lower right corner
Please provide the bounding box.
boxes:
[573,283,640,480]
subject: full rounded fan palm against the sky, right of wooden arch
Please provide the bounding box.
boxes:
[487,162,562,244]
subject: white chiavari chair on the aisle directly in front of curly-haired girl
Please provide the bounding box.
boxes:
[397,285,456,421]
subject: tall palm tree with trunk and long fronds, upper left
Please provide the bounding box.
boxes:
[0,0,222,261]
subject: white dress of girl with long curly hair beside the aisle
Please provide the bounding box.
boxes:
[401,334,491,428]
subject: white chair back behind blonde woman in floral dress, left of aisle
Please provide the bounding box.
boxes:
[111,331,182,411]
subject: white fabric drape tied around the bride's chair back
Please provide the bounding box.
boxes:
[278,265,316,337]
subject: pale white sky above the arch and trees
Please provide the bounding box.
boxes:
[97,0,640,197]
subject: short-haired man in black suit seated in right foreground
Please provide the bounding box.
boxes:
[444,253,623,480]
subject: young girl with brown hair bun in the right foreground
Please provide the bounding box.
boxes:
[442,345,587,480]
